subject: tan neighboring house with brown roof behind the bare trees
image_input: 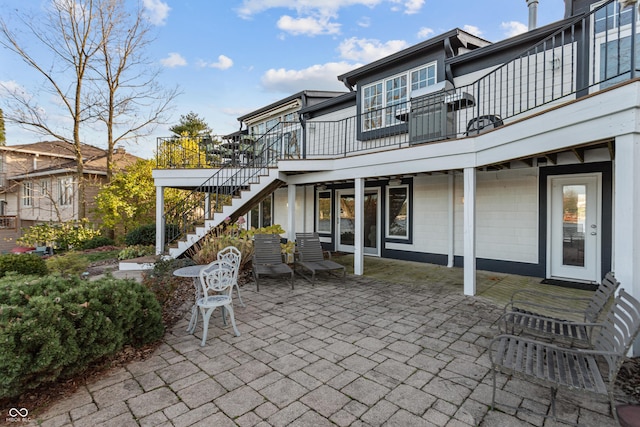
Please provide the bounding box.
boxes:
[0,141,138,251]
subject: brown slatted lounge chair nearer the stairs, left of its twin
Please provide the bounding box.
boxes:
[253,234,293,292]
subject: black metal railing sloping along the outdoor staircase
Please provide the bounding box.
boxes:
[162,123,283,251]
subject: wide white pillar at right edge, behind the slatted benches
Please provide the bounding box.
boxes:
[612,134,640,356]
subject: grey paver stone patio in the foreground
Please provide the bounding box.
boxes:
[34,264,626,427]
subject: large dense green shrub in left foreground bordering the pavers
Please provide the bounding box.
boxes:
[0,274,164,398]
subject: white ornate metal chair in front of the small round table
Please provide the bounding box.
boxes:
[196,260,240,347]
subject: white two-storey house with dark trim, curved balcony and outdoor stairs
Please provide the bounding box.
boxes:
[154,0,640,318]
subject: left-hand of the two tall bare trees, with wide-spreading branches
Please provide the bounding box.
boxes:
[0,0,102,217]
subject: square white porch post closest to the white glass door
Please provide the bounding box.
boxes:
[464,168,476,295]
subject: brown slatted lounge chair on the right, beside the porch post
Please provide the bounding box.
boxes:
[295,233,346,283]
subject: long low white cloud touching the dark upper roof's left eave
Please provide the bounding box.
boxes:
[262,62,360,93]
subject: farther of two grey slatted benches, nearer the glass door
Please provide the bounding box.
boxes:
[499,272,620,347]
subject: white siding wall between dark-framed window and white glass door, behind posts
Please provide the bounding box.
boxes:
[386,168,538,263]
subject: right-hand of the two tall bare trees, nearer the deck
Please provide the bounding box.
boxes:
[92,0,178,181]
